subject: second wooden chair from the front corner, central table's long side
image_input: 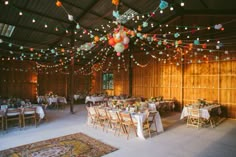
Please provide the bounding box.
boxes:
[107,111,123,135]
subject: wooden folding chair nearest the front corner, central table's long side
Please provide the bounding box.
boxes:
[119,112,138,140]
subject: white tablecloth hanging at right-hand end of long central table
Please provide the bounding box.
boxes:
[132,111,164,139]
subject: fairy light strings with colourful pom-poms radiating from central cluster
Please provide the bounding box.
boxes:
[0,0,236,75]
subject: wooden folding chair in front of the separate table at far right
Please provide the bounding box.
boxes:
[187,108,203,128]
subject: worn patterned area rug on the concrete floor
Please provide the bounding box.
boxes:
[0,133,117,157]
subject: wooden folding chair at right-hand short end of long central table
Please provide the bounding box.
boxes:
[143,111,157,137]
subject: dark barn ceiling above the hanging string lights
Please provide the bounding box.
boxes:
[0,0,236,71]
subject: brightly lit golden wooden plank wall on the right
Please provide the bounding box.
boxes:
[91,56,236,118]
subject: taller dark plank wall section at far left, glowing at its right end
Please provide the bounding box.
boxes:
[0,61,37,100]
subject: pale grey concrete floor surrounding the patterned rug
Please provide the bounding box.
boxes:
[0,105,236,157]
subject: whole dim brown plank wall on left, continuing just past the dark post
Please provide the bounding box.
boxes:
[0,61,90,101]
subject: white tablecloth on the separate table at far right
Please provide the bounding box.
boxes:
[180,105,221,119]
